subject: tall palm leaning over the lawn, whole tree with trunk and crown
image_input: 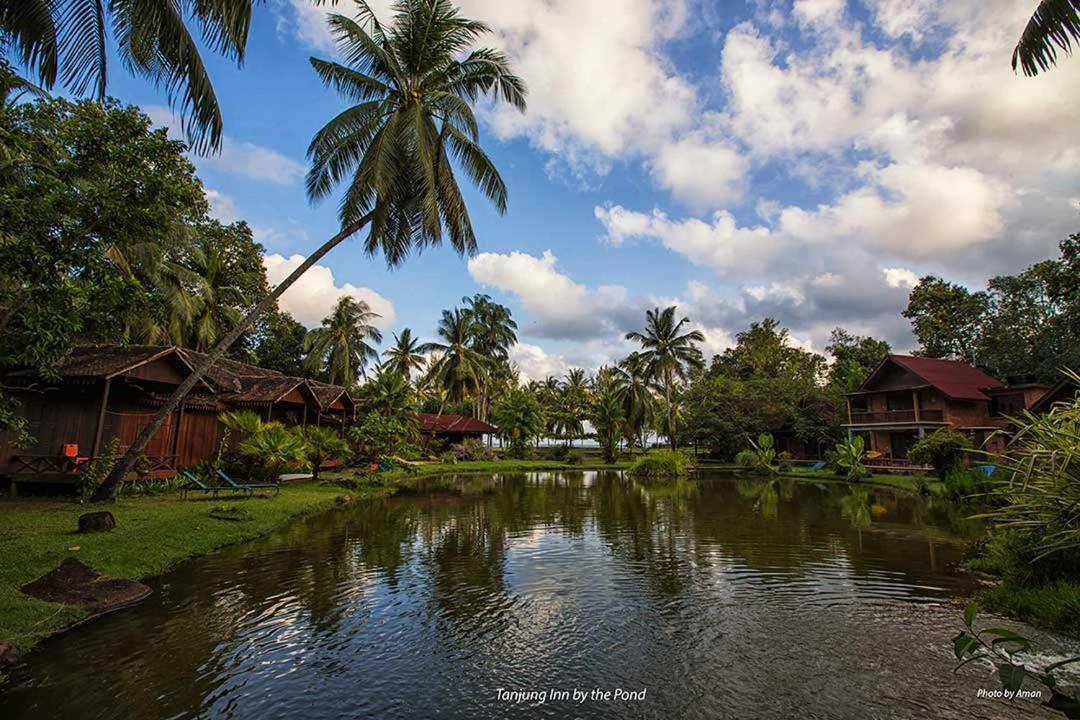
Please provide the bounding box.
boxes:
[92,0,525,501]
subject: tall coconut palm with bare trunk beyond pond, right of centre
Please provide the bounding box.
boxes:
[626,305,705,450]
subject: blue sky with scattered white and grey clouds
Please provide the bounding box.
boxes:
[97,0,1080,379]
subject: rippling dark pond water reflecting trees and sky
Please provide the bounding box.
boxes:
[0,473,1067,720]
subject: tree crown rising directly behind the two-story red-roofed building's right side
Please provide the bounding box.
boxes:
[903,275,986,363]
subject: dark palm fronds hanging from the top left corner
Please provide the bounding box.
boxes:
[0,0,253,151]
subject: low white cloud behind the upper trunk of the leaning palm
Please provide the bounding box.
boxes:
[262,253,395,329]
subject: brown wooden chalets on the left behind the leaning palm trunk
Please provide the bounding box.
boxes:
[0,345,353,490]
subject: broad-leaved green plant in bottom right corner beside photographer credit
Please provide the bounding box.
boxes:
[953,602,1080,718]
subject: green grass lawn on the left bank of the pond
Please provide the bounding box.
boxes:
[0,484,388,649]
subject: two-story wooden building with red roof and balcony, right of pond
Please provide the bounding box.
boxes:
[845,355,1010,462]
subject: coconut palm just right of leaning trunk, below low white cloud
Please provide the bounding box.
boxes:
[303,295,382,388]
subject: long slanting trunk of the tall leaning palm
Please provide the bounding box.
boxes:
[90,213,372,502]
